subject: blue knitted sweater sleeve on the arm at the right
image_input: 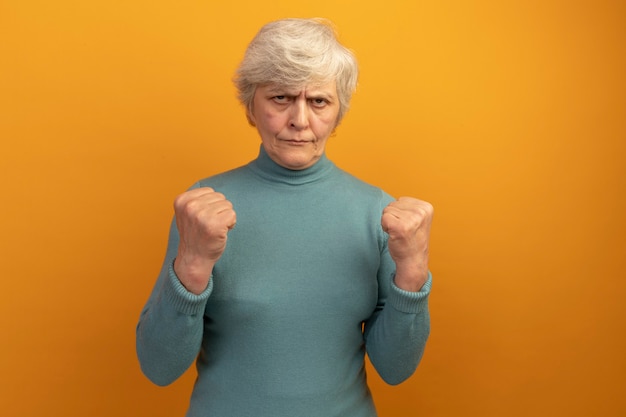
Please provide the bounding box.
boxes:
[364,214,432,385]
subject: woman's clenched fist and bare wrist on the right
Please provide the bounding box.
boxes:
[381,197,433,291]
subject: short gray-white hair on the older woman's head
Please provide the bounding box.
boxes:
[233,18,359,124]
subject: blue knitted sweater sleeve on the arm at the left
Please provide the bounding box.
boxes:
[136,216,213,385]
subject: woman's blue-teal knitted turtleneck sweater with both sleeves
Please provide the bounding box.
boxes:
[137,147,431,417]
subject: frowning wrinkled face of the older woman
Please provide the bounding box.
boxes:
[249,81,339,170]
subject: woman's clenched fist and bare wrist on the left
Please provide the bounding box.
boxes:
[174,187,237,294]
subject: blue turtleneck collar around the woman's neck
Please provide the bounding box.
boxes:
[248,145,335,185]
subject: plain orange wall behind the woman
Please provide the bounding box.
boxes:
[0,0,626,417]
